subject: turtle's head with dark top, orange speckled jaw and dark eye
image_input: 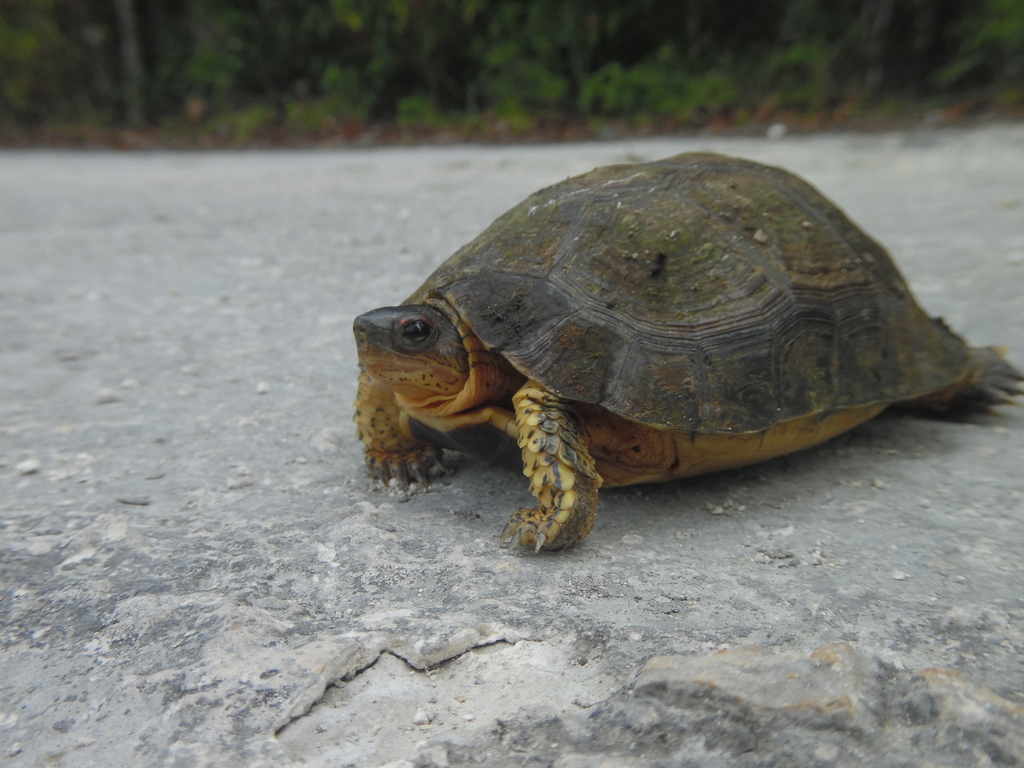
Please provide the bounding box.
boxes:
[352,304,469,400]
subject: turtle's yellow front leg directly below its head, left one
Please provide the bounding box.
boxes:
[352,372,444,488]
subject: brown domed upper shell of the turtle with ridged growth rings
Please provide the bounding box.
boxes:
[407,154,968,433]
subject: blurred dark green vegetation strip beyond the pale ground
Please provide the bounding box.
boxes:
[0,0,1024,131]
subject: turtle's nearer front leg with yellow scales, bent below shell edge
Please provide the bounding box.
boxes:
[501,381,601,551]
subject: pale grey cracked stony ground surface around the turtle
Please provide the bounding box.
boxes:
[0,126,1024,768]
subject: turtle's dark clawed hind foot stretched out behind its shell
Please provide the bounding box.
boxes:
[916,347,1024,412]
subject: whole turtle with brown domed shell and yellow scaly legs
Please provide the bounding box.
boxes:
[353,153,1024,550]
